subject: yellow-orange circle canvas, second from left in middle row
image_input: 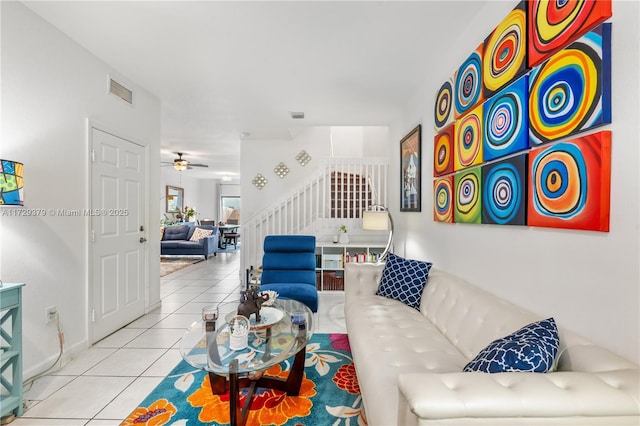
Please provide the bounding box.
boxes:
[453,105,483,171]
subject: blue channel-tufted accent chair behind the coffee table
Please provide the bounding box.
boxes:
[260,235,318,312]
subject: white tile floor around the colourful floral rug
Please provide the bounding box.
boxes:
[11,252,345,426]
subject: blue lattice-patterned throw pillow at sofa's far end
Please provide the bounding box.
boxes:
[376,253,432,310]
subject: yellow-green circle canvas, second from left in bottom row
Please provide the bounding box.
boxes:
[453,167,482,223]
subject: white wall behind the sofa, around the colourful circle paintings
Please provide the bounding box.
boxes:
[389,1,640,362]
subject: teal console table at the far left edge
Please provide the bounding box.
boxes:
[0,283,24,417]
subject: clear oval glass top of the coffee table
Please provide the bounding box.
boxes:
[180,299,313,375]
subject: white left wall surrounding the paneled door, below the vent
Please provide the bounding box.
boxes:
[0,2,160,377]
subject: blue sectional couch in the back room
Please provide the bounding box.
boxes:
[160,225,219,259]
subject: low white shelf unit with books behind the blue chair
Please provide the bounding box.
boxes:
[316,242,386,291]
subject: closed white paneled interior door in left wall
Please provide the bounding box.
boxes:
[90,127,146,343]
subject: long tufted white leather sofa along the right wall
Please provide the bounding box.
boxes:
[344,263,640,426]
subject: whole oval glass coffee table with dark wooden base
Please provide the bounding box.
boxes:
[180,299,313,425]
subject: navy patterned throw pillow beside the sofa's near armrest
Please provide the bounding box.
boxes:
[463,318,560,373]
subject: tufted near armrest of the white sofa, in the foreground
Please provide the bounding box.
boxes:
[398,369,640,423]
